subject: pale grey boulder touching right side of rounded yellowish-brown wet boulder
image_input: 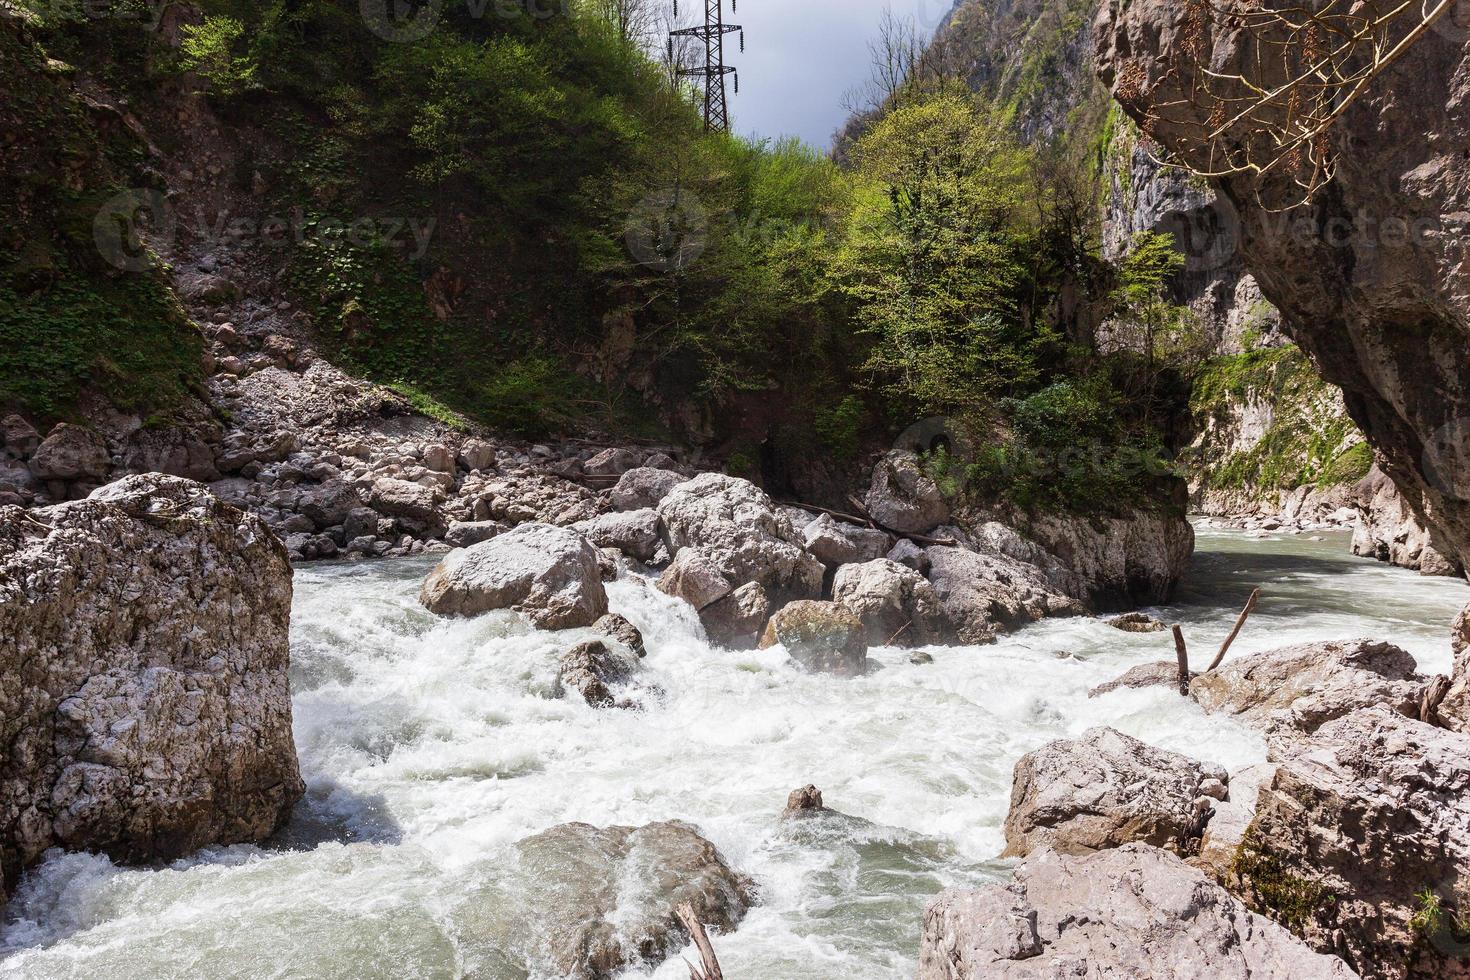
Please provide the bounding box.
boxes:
[832,558,951,646]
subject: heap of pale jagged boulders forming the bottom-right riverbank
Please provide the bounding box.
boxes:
[919,620,1470,980]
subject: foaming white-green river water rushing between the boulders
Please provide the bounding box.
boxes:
[0,530,1470,980]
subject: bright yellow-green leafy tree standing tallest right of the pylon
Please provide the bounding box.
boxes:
[838,91,1054,426]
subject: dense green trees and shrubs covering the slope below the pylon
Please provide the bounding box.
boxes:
[0,0,1198,510]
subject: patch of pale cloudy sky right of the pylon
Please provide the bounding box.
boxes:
[717,0,954,150]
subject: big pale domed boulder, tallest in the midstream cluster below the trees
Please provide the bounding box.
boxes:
[659,473,825,602]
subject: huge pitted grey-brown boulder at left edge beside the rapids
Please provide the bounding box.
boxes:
[0,475,303,895]
